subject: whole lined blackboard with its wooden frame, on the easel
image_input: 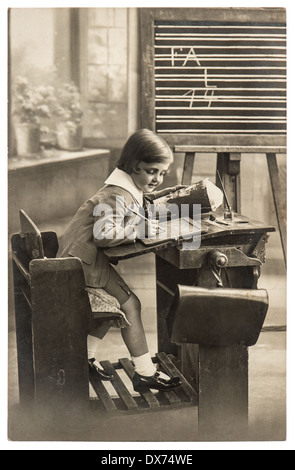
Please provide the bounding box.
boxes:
[141,8,286,149]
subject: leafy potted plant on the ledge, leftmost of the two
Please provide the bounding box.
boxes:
[12,77,54,156]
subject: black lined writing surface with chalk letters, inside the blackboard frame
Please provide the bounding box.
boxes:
[154,22,286,134]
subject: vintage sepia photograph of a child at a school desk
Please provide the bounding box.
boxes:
[6,2,292,448]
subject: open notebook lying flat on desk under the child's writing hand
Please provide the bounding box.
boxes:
[141,217,207,246]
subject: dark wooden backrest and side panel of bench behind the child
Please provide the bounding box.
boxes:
[11,210,94,408]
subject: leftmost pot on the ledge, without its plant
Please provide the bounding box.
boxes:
[15,123,40,157]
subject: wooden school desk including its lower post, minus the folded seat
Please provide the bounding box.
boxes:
[105,213,275,437]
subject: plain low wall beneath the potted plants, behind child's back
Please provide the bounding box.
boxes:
[8,151,110,234]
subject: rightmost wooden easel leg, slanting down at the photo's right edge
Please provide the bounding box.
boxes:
[266,153,287,264]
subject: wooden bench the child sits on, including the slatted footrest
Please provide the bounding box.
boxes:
[11,210,197,413]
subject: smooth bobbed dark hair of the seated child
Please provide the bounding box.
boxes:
[117,129,173,174]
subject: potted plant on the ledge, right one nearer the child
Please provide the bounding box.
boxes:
[54,83,83,151]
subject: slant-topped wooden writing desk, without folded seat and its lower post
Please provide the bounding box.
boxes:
[105,209,275,353]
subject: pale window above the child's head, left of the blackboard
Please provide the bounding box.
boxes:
[80,8,128,146]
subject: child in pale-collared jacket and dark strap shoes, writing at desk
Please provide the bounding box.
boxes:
[57,129,181,391]
